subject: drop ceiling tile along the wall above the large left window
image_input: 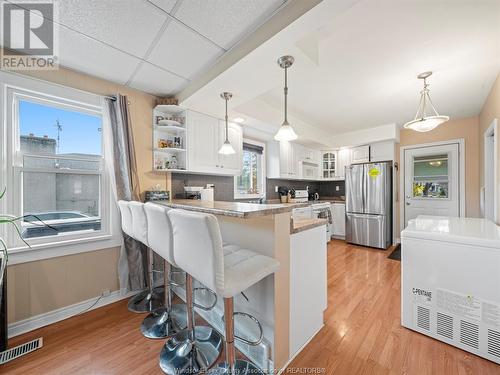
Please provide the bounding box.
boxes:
[59,26,140,84]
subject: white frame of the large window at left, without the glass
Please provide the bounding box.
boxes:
[0,72,122,264]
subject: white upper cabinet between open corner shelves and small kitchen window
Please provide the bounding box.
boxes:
[187,111,243,175]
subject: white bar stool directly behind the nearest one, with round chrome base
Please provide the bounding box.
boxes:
[141,203,187,339]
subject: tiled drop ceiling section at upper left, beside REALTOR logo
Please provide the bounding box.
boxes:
[0,0,288,96]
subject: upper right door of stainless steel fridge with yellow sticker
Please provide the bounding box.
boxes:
[364,163,391,215]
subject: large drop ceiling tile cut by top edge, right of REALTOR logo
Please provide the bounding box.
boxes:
[58,0,168,57]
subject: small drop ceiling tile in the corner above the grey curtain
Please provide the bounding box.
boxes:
[129,62,189,96]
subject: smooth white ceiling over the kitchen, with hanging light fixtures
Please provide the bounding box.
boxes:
[181,0,500,143]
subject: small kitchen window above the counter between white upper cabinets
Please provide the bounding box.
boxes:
[234,141,265,199]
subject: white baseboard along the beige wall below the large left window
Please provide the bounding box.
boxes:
[8,290,137,338]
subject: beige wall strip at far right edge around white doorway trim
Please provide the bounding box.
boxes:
[478,74,500,225]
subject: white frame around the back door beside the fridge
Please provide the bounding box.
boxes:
[399,138,465,231]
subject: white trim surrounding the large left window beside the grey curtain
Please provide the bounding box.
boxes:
[0,72,122,264]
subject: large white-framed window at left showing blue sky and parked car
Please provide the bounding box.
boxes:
[0,74,116,258]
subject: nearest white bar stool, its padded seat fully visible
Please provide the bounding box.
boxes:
[164,210,279,374]
